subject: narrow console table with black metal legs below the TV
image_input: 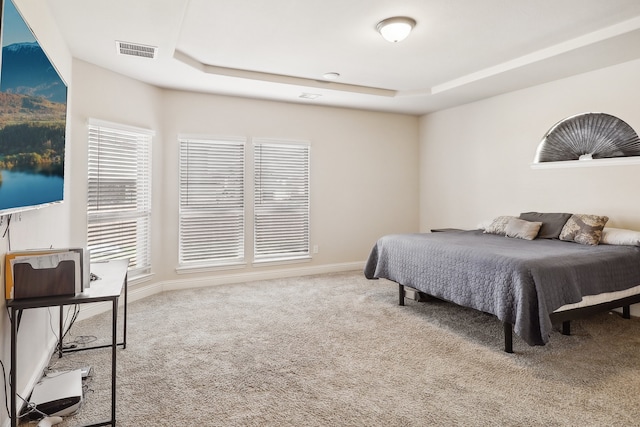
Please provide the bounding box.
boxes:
[7,260,129,427]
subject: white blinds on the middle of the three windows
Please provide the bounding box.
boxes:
[179,139,245,266]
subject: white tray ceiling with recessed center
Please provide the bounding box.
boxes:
[47,0,640,114]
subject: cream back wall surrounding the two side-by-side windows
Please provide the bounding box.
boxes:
[160,91,418,286]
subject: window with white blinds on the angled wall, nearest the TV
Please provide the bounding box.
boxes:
[87,120,153,277]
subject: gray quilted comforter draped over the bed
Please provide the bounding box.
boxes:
[364,230,640,345]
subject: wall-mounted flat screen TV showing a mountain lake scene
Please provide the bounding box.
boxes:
[0,0,67,216]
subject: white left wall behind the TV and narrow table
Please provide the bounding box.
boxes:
[0,0,73,425]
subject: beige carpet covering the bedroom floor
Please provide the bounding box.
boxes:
[27,272,640,426]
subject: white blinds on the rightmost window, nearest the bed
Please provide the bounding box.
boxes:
[254,140,310,262]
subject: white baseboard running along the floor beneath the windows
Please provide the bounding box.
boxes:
[78,261,364,320]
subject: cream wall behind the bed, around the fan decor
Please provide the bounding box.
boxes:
[420,61,640,230]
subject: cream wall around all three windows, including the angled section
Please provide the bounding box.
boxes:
[71,60,418,287]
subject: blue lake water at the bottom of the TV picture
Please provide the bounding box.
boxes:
[0,170,64,210]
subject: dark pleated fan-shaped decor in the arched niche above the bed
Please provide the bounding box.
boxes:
[534,113,640,168]
